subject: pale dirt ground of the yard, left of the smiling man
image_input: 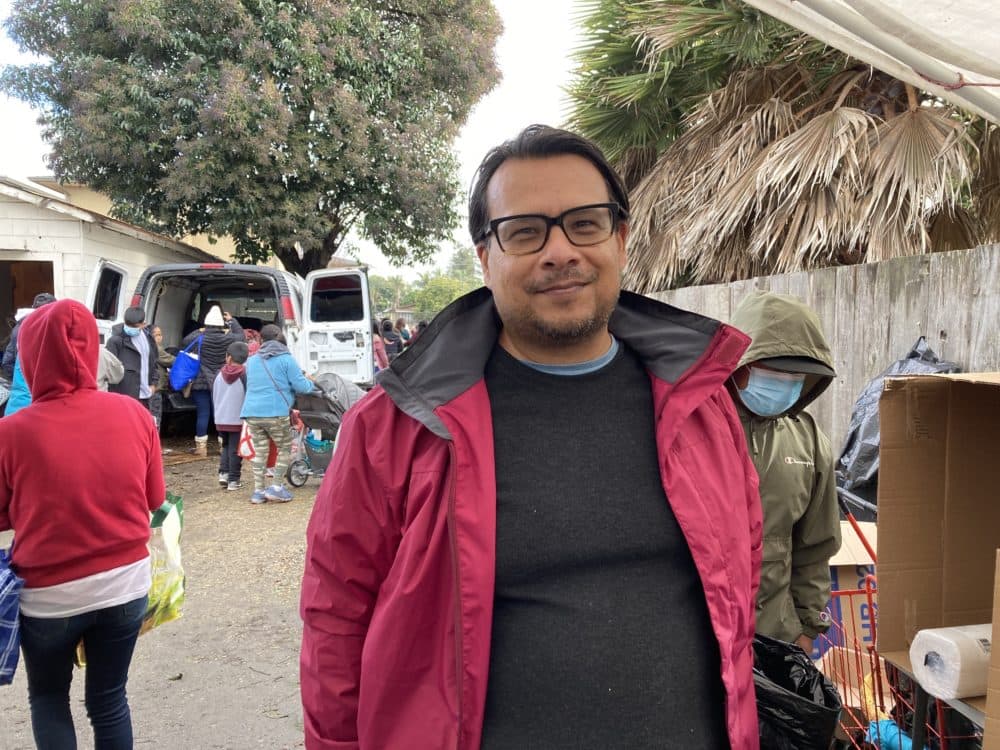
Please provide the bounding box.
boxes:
[0,440,320,750]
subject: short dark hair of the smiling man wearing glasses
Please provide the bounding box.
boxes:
[469,125,629,245]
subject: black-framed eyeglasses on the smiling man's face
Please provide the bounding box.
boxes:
[483,203,628,255]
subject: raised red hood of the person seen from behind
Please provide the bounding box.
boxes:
[18,299,100,402]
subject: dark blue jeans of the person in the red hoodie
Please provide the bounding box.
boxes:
[21,596,146,750]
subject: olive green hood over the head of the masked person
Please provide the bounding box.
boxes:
[730,291,836,415]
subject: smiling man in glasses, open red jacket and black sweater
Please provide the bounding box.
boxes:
[301,126,761,750]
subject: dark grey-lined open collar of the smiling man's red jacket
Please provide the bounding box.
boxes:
[378,287,747,439]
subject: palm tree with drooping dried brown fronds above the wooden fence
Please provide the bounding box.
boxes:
[571,0,1000,292]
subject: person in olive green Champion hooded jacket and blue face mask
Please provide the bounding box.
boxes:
[730,291,840,653]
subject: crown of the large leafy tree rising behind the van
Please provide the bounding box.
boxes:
[0,0,501,272]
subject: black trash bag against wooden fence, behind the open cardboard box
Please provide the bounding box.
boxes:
[837,336,962,502]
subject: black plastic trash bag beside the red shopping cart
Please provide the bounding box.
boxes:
[753,633,841,750]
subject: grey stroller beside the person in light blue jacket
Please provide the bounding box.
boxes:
[288,372,365,487]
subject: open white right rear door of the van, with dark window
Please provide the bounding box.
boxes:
[299,266,375,387]
